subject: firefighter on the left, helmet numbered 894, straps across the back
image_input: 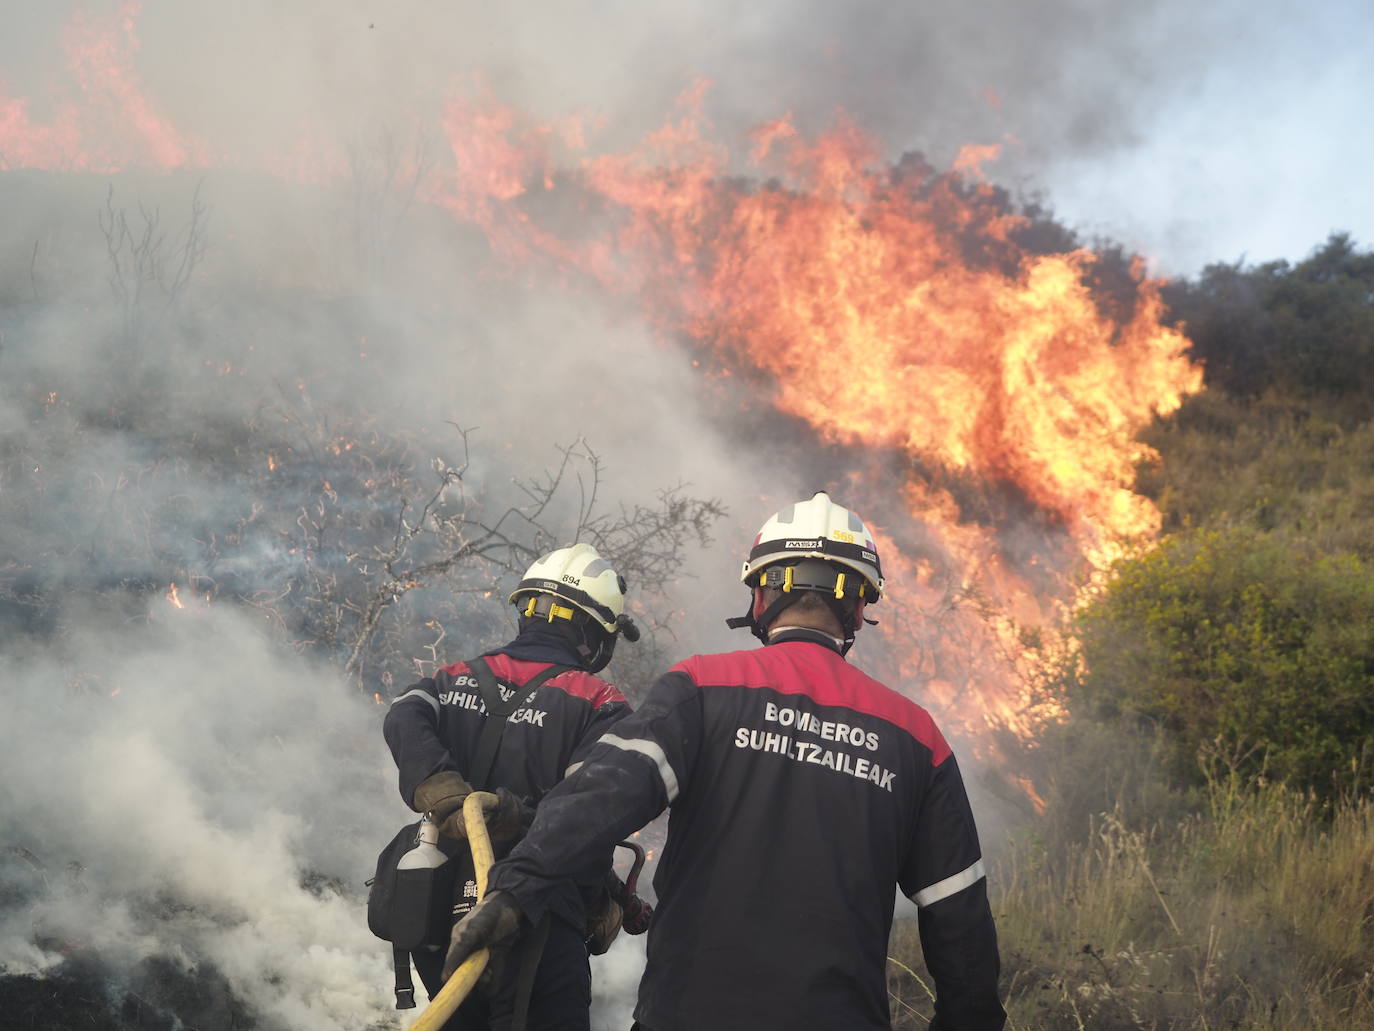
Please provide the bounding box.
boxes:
[383,543,639,1031]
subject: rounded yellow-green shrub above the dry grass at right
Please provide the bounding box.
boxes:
[1072,529,1374,792]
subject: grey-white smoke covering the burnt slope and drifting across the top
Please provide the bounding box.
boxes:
[0,0,1247,1031]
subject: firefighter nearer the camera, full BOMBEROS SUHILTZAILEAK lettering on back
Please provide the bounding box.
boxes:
[445,492,1006,1031]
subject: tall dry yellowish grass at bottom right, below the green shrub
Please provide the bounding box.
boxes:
[889,753,1374,1031]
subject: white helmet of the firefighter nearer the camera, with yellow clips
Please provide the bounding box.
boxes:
[739,491,882,603]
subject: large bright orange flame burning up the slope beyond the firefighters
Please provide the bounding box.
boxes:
[436,87,1202,735]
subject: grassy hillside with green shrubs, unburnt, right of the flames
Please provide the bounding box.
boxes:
[889,236,1374,1031]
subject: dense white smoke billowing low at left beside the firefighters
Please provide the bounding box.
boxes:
[0,606,404,1030]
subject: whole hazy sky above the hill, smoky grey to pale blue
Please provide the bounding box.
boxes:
[0,0,1374,274]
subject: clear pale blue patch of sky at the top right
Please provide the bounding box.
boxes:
[1029,0,1374,274]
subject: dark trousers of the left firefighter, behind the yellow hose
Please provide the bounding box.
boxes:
[411,917,592,1031]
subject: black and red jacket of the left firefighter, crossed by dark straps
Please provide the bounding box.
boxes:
[382,621,629,924]
